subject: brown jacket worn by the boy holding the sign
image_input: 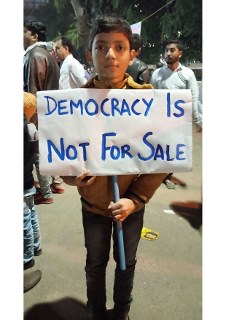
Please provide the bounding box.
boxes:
[74,74,167,216]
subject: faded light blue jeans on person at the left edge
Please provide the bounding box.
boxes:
[24,187,41,263]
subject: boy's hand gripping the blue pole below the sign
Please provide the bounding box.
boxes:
[108,198,136,222]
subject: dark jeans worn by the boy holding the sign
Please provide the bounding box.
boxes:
[82,208,144,317]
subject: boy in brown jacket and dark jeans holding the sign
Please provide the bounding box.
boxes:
[63,16,166,320]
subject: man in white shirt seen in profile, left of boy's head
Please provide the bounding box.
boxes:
[55,36,87,90]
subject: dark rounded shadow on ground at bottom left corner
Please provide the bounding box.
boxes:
[24,297,89,320]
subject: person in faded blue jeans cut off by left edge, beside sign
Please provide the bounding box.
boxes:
[23,93,42,270]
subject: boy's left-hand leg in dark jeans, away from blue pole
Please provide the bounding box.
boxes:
[82,209,112,320]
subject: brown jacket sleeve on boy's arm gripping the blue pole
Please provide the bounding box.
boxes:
[125,173,167,210]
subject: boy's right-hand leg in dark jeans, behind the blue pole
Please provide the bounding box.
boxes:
[113,209,144,320]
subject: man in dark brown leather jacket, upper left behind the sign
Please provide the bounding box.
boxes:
[24,20,64,204]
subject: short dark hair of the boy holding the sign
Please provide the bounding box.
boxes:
[89,16,133,51]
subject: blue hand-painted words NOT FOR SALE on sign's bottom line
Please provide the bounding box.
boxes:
[47,132,186,163]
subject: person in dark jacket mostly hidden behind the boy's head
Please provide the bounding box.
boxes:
[126,33,150,84]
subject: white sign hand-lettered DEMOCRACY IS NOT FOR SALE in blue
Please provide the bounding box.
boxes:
[37,88,192,176]
